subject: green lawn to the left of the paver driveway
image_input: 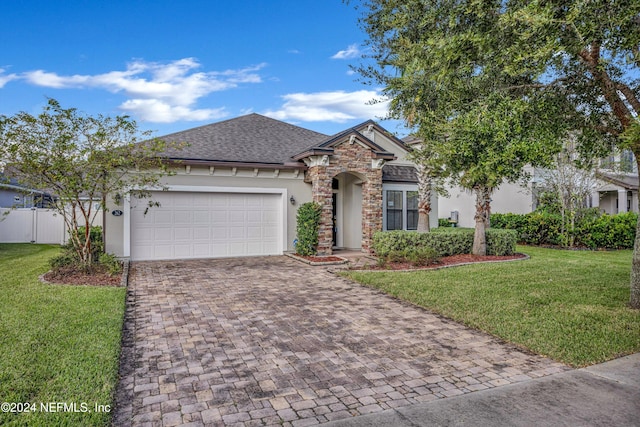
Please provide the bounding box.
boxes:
[0,244,125,426]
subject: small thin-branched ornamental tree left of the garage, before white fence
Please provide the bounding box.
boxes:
[0,99,180,272]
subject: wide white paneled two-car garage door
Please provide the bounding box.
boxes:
[131,192,282,260]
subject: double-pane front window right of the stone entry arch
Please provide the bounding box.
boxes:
[383,185,418,231]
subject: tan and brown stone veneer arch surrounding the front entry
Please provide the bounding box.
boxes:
[307,140,383,255]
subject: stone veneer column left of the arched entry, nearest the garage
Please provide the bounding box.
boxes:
[308,166,333,255]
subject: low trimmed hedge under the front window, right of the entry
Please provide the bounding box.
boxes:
[373,227,517,258]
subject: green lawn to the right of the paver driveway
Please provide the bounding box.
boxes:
[345,246,640,367]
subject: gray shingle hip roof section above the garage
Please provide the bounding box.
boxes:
[160,113,328,164]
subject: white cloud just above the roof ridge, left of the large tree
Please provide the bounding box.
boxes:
[263,90,389,123]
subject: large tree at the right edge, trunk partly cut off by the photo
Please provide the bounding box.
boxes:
[500,0,640,309]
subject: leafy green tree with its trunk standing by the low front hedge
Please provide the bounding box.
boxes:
[350,0,563,255]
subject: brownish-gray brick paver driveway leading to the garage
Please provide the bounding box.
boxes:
[114,257,567,426]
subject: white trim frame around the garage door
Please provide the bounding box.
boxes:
[122,185,289,257]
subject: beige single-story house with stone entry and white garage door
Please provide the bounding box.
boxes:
[105,114,437,260]
